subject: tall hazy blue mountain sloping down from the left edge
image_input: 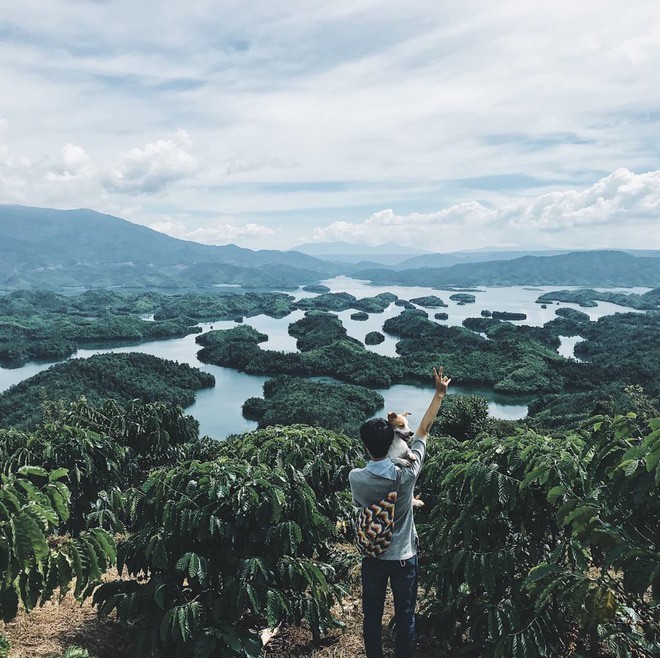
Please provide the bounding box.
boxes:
[0,205,337,289]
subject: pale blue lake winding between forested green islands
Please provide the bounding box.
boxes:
[0,276,648,439]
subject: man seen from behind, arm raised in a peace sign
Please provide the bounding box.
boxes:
[348,367,451,658]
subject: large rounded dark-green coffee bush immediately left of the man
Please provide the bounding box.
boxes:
[94,458,340,657]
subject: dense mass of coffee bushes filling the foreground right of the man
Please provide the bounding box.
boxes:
[420,415,660,657]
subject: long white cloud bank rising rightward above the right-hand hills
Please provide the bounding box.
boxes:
[314,169,660,251]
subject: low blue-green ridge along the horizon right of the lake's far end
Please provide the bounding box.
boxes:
[353,251,660,288]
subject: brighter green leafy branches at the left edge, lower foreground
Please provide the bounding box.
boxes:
[0,466,115,621]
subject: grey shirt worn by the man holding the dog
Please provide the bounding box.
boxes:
[348,437,426,560]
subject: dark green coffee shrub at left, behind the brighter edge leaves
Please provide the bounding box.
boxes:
[0,399,197,534]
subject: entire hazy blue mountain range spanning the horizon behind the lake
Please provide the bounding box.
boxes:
[0,205,660,290]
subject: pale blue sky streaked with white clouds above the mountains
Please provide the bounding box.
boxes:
[0,0,660,252]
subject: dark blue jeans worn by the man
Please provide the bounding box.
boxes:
[362,555,418,658]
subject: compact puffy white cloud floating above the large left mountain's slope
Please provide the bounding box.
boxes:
[103,130,199,194]
